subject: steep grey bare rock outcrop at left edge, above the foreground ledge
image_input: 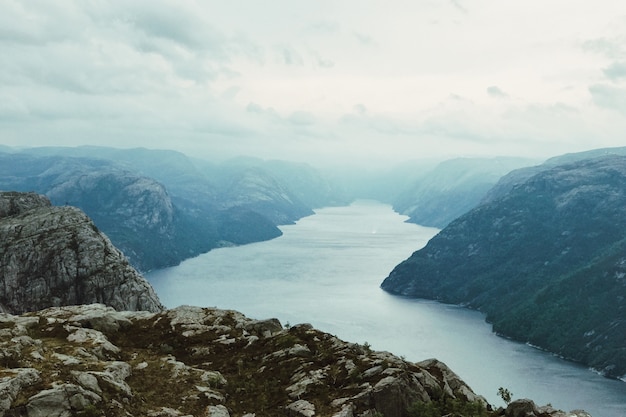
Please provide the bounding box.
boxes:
[0,192,163,313]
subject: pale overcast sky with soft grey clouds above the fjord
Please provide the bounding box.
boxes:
[0,0,626,167]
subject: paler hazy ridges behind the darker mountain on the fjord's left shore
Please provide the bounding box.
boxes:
[18,146,348,225]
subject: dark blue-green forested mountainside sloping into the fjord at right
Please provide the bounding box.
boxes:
[381,155,626,377]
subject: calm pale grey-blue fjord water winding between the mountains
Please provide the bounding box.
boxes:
[147,201,626,417]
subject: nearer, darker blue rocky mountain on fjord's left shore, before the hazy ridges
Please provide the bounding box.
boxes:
[0,153,281,271]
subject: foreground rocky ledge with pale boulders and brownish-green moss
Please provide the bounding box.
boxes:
[0,304,584,417]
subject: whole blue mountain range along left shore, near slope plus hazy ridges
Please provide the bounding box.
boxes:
[0,146,347,271]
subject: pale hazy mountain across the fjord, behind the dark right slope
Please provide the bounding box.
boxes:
[393,157,531,228]
